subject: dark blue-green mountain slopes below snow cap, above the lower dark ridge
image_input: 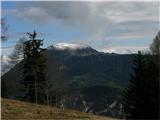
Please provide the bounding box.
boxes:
[2,46,133,98]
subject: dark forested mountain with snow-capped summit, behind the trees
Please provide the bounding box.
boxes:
[2,44,134,117]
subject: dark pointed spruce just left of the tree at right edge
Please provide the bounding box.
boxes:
[123,51,147,119]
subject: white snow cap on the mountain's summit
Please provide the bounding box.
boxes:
[53,43,90,50]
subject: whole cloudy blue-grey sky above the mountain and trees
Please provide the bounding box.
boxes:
[1,1,160,55]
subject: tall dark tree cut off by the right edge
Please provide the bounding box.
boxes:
[146,31,160,119]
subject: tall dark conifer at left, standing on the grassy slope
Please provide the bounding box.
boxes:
[23,31,46,103]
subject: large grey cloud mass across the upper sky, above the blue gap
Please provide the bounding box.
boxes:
[2,1,159,49]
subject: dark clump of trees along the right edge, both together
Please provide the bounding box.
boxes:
[123,32,160,119]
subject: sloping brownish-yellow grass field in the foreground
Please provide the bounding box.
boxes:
[1,99,115,120]
